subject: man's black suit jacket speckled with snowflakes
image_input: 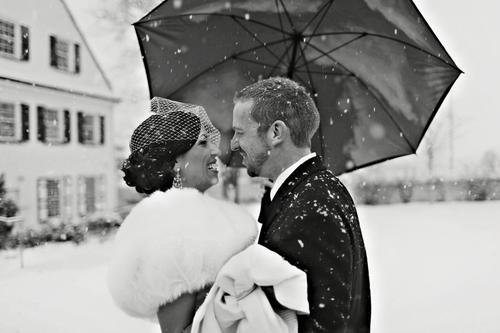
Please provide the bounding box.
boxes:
[259,157,371,333]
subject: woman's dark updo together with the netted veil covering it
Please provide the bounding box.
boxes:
[121,97,220,194]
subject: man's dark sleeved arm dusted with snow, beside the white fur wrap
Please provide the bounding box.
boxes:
[274,188,353,332]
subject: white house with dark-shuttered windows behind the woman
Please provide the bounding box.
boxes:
[0,0,119,226]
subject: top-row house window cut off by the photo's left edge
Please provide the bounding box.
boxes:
[0,18,29,61]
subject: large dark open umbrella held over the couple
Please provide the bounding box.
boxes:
[134,0,461,174]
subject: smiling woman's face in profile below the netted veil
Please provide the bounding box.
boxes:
[177,133,220,192]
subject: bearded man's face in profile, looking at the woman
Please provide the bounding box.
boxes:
[231,100,270,177]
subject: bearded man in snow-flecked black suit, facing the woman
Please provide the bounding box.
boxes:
[231,78,371,333]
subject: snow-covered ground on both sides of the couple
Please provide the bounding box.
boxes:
[0,201,500,333]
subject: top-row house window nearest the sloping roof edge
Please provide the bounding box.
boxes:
[50,36,81,73]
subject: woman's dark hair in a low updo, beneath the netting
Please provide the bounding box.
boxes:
[121,112,201,194]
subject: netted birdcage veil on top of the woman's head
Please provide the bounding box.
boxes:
[130,97,220,152]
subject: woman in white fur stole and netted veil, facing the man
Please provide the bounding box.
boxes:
[108,97,308,333]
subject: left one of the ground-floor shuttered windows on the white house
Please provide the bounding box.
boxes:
[37,177,72,223]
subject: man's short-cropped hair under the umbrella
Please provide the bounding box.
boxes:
[234,77,319,147]
